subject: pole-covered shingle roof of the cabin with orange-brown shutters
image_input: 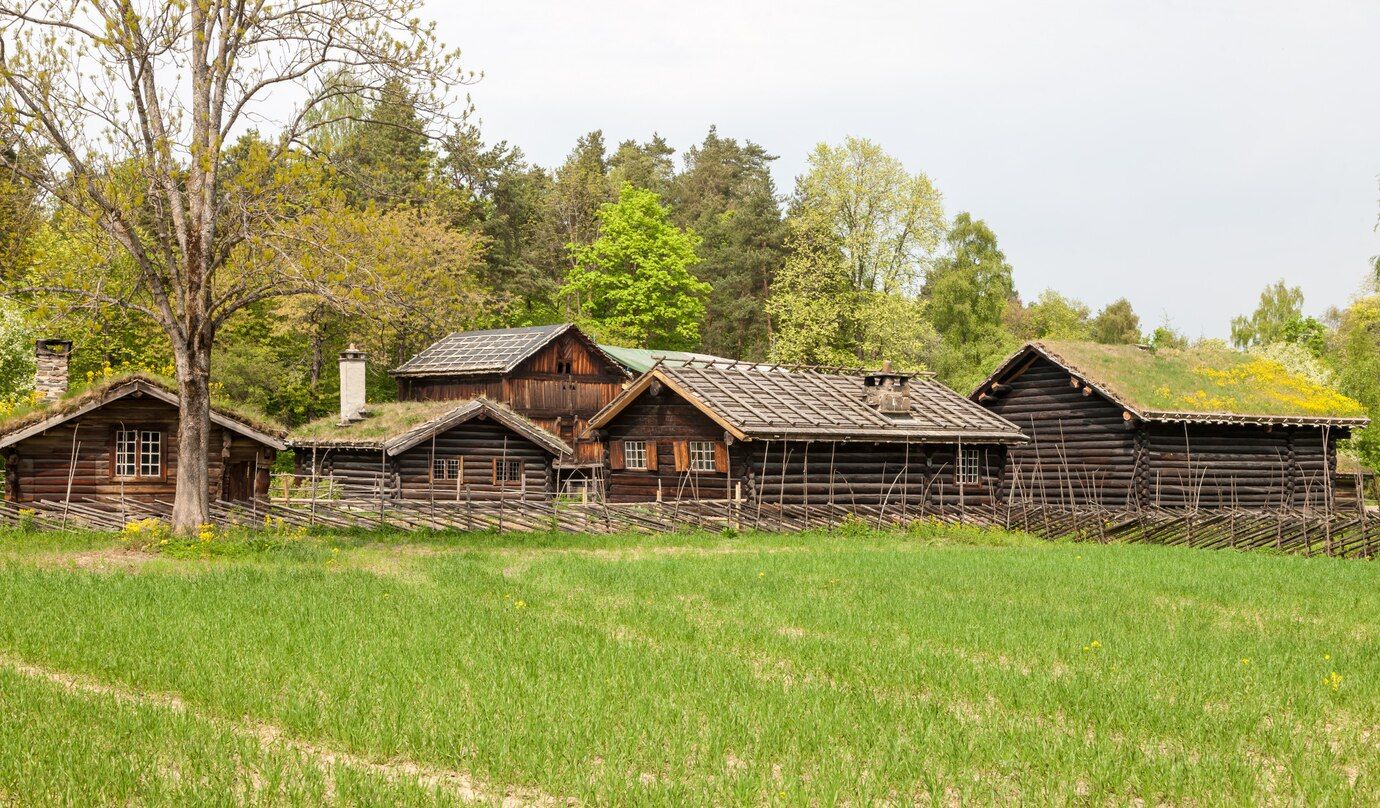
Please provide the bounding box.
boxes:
[589,363,1025,443]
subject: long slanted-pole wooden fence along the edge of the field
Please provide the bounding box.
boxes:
[0,499,1380,558]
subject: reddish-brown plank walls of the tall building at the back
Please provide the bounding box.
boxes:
[397,332,627,463]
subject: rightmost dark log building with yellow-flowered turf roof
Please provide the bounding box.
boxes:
[972,342,1368,509]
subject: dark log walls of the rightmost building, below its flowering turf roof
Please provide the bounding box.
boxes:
[983,357,1347,507]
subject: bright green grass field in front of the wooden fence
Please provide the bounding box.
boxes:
[0,521,1380,805]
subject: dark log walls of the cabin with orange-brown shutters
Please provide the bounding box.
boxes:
[604,385,1006,506]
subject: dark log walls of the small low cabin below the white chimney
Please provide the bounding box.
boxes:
[295,421,552,502]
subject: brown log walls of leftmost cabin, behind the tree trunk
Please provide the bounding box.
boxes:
[6,396,275,502]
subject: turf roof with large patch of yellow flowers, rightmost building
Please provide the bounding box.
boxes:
[984,341,1366,421]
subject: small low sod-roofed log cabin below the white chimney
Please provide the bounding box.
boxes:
[290,398,570,502]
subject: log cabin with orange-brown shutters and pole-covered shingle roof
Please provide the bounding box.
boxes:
[589,361,1025,506]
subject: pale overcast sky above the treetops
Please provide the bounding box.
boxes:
[429,0,1380,336]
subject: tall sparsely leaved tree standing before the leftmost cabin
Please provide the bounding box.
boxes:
[0,0,471,532]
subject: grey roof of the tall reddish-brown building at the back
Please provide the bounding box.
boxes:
[389,323,622,376]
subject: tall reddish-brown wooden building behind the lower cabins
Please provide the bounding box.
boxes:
[389,323,629,469]
